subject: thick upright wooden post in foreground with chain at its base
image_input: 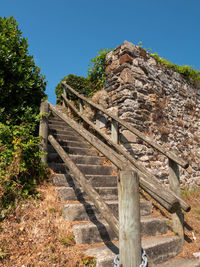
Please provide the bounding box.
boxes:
[118,170,141,267]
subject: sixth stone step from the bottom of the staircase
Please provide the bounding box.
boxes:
[49,163,113,175]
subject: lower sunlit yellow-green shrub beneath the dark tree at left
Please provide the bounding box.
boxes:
[0,120,46,219]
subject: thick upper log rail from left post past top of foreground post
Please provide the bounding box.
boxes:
[49,103,187,213]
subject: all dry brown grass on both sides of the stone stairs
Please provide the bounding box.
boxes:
[0,184,200,267]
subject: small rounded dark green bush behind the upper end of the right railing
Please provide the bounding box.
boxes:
[55,74,91,104]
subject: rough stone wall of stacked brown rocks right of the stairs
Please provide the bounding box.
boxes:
[106,41,200,188]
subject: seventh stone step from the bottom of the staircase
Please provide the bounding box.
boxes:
[48,153,103,165]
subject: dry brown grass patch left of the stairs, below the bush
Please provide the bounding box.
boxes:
[0,185,92,267]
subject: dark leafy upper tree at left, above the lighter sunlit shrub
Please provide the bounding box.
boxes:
[0,17,46,123]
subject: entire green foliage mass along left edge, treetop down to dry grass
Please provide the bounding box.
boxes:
[0,17,46,219]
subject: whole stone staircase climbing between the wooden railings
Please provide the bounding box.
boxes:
[48,114,182,267]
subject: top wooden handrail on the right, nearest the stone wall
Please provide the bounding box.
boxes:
[62,82,189,169]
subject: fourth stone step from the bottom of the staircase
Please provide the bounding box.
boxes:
[56,186,118,201]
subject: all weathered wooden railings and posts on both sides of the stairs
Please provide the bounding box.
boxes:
[40,82,190,266]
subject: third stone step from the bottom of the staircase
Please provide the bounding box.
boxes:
[63,200,152,221]
